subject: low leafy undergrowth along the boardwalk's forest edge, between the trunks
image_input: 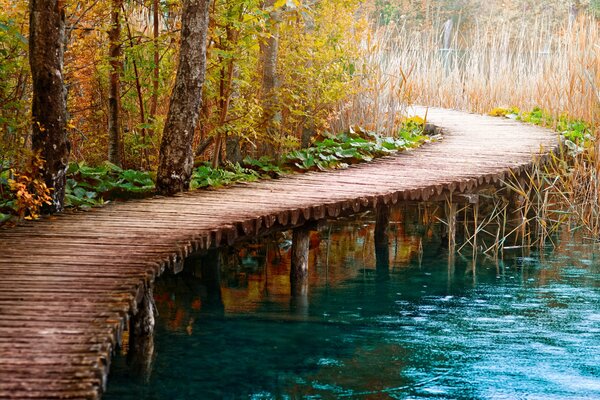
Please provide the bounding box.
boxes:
[0,117,435,225]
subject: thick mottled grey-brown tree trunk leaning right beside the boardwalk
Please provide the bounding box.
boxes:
[156,0,210,194]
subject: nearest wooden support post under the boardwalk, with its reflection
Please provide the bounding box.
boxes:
[127,283,156,381]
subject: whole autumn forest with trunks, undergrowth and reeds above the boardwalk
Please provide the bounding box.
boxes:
[0,0,600,222]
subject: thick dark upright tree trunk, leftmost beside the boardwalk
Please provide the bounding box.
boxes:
[29,0,70,212]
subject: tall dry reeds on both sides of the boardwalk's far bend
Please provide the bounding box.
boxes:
[337,15,600,241]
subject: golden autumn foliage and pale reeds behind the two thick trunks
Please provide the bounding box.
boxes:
[0,0,600,222]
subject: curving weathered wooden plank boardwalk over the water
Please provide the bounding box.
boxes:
[0,109,558,399]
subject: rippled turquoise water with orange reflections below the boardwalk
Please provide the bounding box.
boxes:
[104,220,600,399]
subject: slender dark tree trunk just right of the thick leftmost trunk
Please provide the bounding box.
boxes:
[108,0,123,166]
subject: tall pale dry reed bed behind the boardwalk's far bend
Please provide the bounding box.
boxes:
[339,15,600,134]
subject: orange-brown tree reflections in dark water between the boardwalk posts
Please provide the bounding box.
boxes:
[154,208,442,334]
